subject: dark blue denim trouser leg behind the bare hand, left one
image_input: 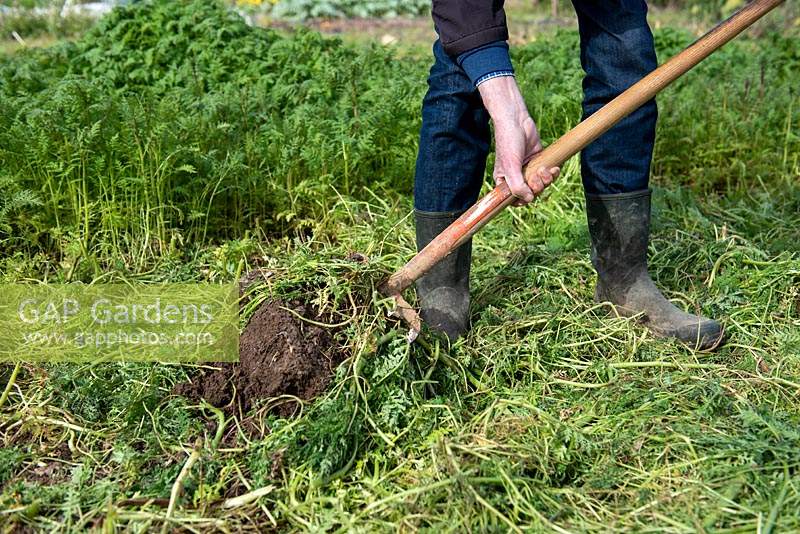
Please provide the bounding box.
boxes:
[414,41,491,212]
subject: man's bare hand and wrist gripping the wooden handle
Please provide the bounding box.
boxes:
[478,76,560,206]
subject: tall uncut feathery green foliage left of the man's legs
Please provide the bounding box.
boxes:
[0,2,424,276]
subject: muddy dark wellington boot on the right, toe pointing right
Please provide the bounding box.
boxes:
[586,190,723,349]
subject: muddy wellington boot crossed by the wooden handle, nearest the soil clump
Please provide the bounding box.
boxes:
[414,211,472,341]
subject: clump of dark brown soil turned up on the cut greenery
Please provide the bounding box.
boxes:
[175,301,344,416]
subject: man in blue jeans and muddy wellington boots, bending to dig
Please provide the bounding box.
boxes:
[414,0,723,348]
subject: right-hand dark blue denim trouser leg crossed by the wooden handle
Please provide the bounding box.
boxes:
[572,0,658,194]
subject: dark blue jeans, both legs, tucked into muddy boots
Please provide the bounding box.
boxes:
[414,0,658,212]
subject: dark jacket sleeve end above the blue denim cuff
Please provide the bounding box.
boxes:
[432,0,508,56]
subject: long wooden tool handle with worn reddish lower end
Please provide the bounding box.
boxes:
[380,0,783,296]
